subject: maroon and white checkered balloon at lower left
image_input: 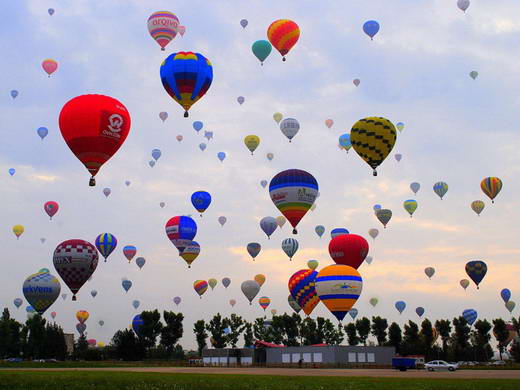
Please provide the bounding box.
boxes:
[53,239,98,301]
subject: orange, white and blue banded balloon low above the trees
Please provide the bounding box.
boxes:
[316,264,363,321]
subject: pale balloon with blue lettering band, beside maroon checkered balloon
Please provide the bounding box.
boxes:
[22,272,61,314]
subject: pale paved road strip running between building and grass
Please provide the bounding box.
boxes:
[4,367,520,379]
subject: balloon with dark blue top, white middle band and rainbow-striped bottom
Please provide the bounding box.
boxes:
[269,169,319,234]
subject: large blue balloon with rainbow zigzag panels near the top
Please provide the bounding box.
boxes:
[161,51,213,118]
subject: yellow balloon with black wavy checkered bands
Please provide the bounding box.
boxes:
[350,117,397,176]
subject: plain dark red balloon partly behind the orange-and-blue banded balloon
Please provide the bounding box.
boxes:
[329,234,368,269]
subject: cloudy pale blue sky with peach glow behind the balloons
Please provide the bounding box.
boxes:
[0,0,520,348]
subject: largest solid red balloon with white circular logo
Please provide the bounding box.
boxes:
[59,95,130,186]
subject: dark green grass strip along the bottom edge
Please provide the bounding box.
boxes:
[0,371,520,390]
